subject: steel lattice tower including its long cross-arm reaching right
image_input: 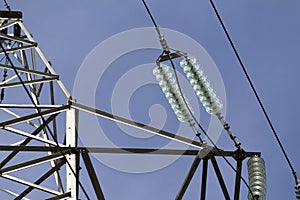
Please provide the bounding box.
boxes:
[0,11,260,200]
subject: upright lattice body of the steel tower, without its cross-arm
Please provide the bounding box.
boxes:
[0,11,78,199]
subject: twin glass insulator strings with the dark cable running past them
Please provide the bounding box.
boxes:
[142,0,254,199]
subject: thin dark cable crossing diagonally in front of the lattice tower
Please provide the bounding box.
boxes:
[0,43,90,200]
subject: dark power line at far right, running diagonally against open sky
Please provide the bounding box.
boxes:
[210,0,298,183]
